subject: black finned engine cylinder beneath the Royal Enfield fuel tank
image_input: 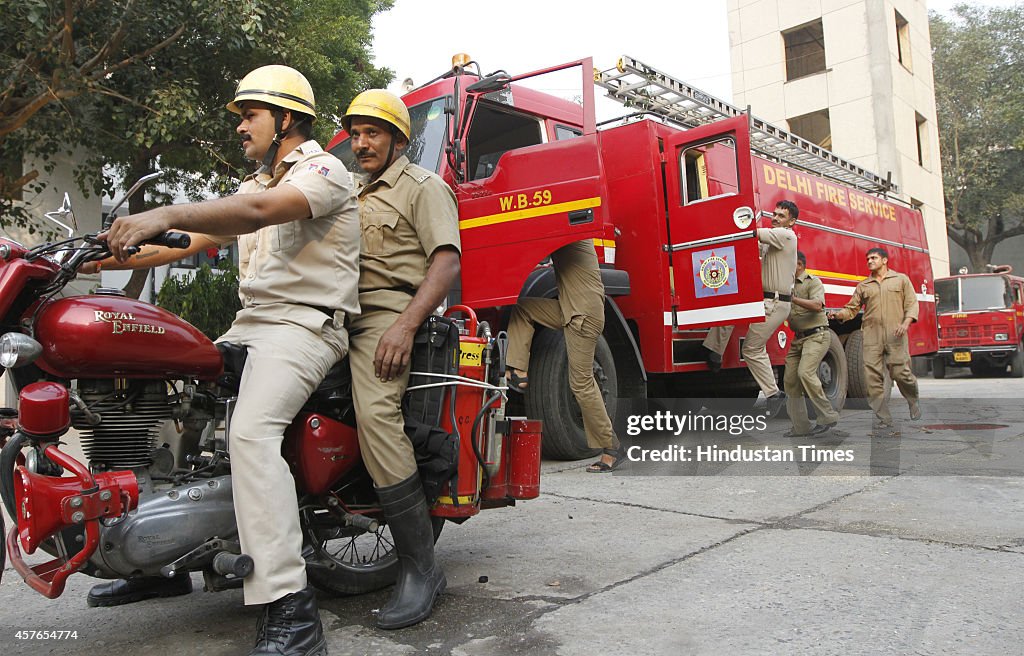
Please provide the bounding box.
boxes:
[71,379,172,471]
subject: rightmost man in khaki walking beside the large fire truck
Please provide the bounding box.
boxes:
[829,248,921,432]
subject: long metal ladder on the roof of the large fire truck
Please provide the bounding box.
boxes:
[594,55,899,193]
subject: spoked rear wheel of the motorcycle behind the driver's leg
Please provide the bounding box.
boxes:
[302,509,444,595]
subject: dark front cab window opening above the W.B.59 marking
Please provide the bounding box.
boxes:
[467,102,544,180]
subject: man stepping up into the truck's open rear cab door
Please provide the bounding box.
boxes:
[703,201,800,417]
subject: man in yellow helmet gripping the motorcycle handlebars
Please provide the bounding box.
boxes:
[89,65,359,656]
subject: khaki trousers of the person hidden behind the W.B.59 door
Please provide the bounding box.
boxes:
[507,298,618,449]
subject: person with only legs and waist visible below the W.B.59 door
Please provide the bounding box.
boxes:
[506,239,624,474]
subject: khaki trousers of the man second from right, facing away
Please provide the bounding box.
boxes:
[782,331,839,433]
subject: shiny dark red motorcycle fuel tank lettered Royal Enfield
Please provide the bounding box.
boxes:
[36,294,223,380]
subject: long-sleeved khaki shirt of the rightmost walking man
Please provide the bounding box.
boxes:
[836,269,918,344]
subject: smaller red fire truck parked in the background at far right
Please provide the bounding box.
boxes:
[932,265,1024,378]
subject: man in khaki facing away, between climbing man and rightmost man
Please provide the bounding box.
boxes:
[783,251,839,437]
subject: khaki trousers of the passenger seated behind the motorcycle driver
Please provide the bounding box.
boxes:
[348,310,417,487]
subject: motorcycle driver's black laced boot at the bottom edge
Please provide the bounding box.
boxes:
[249,585,327,656]
